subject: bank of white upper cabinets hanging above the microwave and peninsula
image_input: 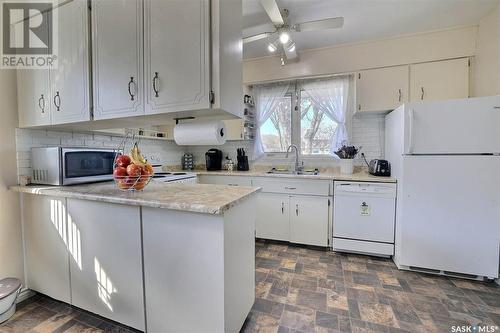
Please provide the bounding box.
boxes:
[18,0,243,127]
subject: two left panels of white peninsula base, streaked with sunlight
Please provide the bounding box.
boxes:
[23,194,145,331]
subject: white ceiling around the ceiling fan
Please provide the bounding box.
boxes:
[243,0,500,59]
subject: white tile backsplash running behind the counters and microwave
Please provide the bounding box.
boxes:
[16,115,385,182]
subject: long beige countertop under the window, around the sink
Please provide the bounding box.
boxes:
[194,170,396,183]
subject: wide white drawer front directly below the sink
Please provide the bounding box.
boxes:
[252,178,332,195]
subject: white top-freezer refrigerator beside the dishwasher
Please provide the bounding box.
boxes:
[385,95,500,278]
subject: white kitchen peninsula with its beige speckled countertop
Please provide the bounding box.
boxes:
[12,182,259,332]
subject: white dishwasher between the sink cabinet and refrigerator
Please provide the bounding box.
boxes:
[333,181,396,256]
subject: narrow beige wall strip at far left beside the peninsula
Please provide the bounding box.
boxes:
[0,69,24,281]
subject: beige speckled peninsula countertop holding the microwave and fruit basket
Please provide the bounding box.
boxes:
[11,180,260,215]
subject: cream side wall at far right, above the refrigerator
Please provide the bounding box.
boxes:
[474,5,500,96]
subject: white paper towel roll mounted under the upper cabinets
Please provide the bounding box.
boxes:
[174,121,227,146]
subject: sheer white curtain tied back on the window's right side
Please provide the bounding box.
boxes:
[302,76,349,155]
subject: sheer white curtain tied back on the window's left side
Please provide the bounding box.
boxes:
[253,83,290,159]
